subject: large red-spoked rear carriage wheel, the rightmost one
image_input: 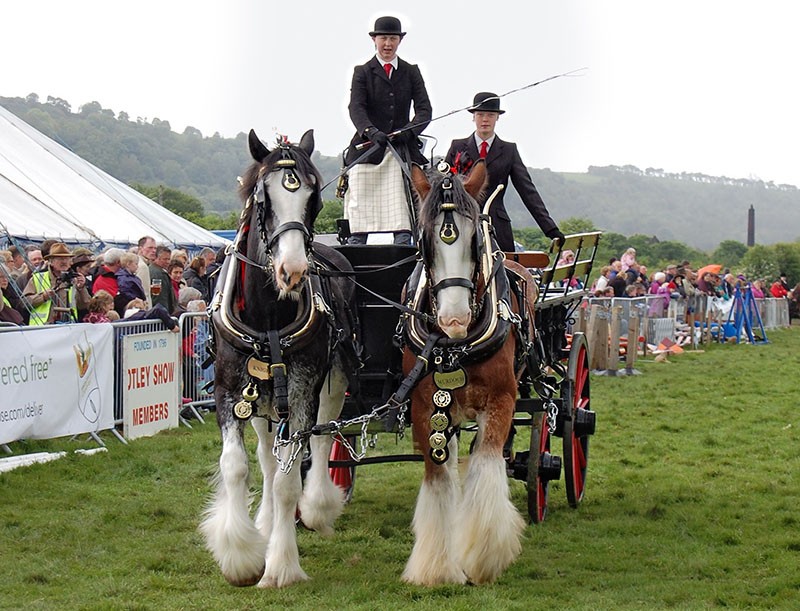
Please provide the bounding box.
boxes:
[561,333,595,507]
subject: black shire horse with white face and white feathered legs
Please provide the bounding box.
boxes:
[200,130,357,587]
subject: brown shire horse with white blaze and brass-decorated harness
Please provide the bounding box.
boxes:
[403,162,537,585]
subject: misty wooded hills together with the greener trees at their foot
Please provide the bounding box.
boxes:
[0,94,800,282]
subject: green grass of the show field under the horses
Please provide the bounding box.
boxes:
[0,328,800,610]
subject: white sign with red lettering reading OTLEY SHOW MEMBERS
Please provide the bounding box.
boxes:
[122,331,181,439]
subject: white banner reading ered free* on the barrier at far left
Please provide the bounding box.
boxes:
[0,324,114,443]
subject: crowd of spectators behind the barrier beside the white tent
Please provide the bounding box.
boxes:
[0,236,223,331]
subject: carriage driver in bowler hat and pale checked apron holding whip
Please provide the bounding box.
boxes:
[344,17,432,244]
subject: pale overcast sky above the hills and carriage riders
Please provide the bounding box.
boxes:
[6,0,800,185]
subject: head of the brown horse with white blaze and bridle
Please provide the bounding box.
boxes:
[412,162,486,339]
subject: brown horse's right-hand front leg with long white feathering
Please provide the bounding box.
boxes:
[456,400,525,584]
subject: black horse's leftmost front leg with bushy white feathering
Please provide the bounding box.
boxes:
[200,406,267,586]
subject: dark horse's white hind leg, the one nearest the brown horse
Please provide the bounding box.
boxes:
[300,367,347,536]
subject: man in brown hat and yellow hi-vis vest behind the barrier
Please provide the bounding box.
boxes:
[23,242,90,326]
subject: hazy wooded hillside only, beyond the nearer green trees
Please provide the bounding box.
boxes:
[0,94,800,252]
